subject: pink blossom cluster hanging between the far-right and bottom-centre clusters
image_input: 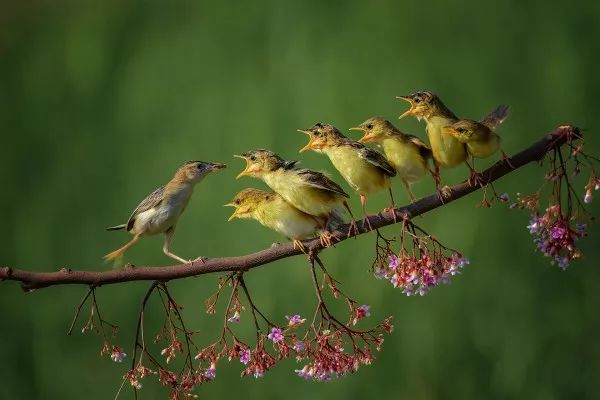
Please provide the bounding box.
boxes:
[375,251,469,296]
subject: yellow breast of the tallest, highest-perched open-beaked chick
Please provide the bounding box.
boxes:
[427,116,467,168]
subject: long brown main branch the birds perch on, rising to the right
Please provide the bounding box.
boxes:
[0,125,582,291]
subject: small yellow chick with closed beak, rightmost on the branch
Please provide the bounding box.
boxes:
[443,105,509,159]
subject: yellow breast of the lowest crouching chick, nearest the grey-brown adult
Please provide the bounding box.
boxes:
[253,197,320,240]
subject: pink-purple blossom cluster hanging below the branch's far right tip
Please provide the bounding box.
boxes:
[527,204,586,270]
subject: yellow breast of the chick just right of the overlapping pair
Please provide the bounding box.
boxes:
[323,146,390,194]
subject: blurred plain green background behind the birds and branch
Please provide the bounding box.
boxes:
[0,0,600,400]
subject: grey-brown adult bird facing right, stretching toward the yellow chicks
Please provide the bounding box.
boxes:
[104,161,226,263]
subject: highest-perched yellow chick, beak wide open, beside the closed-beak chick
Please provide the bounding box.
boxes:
[396,91,467,187]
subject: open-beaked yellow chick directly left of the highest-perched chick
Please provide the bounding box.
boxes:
[350,117,432,203]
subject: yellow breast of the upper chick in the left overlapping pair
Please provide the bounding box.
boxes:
[263,170,344,216]
